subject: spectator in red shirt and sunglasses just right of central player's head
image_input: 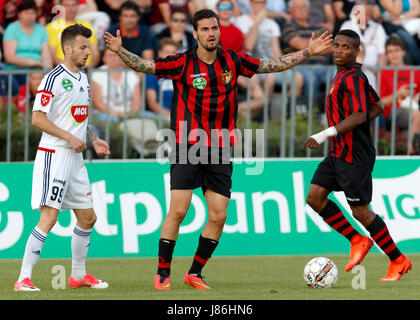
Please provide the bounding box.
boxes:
[216,0,264,116]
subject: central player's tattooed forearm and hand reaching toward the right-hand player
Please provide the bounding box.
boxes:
[257,31,333,73]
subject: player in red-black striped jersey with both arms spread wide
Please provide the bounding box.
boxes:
[105,9,332,290]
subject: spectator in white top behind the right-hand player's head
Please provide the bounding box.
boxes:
[341,1,387,87]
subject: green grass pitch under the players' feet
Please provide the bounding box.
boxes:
[0,254,420,300]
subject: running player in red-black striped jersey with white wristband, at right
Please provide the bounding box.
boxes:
[304,30,412,281]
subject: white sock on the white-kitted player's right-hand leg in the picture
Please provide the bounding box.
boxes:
[71,225,92,280]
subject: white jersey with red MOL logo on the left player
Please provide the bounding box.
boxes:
[33,64,90,147]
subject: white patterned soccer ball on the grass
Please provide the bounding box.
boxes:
[303,257,338,288]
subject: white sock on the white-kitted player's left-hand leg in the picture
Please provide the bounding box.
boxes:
[18,227,47,281]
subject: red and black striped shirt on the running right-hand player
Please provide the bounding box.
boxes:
[326,63,379,170]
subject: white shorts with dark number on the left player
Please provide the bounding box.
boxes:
[31,145,93,210]
